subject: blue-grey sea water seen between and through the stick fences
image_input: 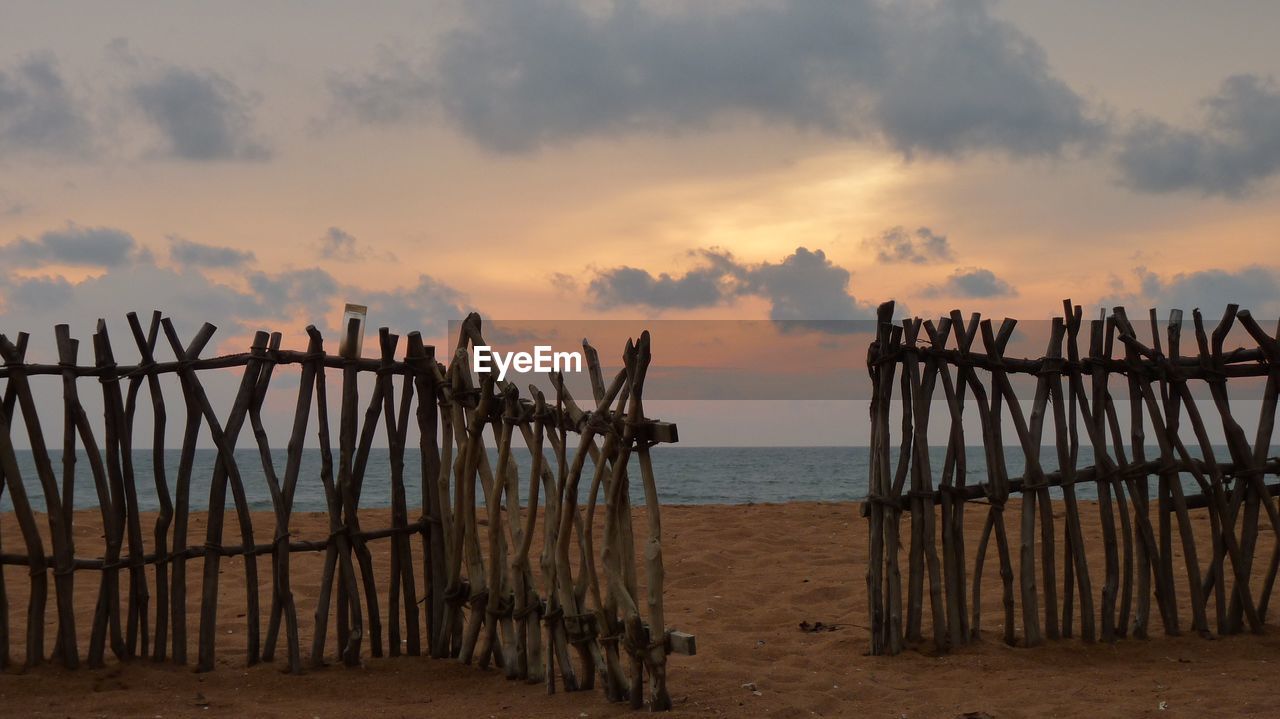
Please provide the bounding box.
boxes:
[0,445,1225,512]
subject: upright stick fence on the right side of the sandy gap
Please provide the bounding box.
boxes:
[864,301,1280,654]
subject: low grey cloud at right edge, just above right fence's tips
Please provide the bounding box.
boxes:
[1098,265,1280,316]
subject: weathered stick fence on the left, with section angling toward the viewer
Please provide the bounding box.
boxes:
[0,312,694,710]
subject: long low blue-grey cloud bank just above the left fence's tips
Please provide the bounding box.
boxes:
[0,220,466,336]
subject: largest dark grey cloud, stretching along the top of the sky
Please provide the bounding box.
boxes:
[330,0,1101,156]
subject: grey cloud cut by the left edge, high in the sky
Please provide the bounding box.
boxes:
[0,54,91,156]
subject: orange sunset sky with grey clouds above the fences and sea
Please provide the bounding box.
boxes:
[0,0,1280,444]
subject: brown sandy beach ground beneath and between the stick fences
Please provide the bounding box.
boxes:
[0,503,1280,718]
